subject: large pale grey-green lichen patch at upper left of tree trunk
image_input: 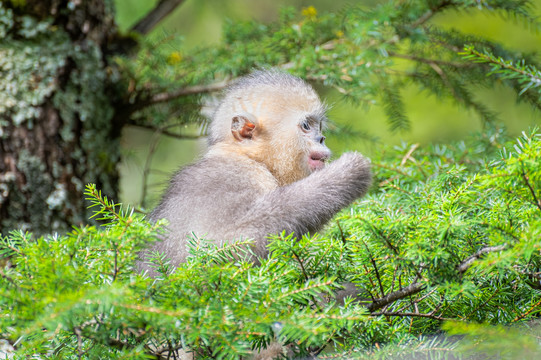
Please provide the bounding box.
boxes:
[0,4,69,131]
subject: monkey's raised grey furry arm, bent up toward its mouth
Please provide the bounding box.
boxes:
[239,153,371,239]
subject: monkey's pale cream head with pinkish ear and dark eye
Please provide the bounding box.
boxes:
[209,73,330,186]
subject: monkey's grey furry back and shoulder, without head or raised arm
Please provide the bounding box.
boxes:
[140,153,278,269]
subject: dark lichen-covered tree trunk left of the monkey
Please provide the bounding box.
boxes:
[0,0,122,235]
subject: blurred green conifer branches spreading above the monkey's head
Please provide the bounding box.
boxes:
[119,0,541,131]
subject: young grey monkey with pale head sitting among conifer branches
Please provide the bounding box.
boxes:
[139,71,371,273]
